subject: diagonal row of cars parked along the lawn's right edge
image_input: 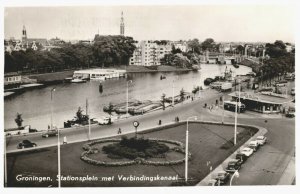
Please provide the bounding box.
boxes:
[208,136,267,186]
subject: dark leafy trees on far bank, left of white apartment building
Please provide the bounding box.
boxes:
[4,35,135,73]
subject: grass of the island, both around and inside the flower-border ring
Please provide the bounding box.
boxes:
[7,121,258,187]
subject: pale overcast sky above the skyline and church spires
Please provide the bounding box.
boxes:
[4,5,296,42]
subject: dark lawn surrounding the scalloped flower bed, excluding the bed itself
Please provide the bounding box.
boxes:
[7,123,256,187]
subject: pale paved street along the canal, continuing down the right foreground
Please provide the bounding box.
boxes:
[7,87,295,185]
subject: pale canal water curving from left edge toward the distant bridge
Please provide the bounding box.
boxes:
[4,64,251,130]
